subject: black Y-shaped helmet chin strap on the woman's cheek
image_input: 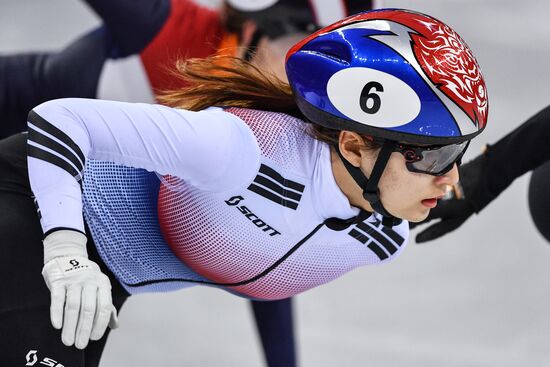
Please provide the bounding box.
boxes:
[336,140,402,227]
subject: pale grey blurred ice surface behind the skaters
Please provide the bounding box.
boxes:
[0,0,550,367]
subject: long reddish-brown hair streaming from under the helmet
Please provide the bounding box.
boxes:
[157,55,378,149]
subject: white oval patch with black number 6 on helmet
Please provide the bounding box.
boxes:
[327,68,420,127]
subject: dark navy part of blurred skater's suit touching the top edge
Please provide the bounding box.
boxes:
[86,0,170,59]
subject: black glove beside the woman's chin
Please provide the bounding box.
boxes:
[410,154,487,243]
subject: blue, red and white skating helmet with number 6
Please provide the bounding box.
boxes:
[286,9,488,145]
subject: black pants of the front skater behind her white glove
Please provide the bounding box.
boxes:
[0,134,128,367]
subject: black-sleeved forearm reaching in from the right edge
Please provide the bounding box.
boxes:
[472,106,550,211]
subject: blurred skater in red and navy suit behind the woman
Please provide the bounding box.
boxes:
[0,0,380,367]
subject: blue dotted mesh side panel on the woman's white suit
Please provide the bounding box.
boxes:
[83,159,204,293]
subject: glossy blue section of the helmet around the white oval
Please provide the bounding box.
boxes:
[286,29,461,142]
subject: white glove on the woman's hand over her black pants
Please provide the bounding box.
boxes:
[42,230,118,349]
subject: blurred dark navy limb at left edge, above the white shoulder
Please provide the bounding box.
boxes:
[0,27,110,139]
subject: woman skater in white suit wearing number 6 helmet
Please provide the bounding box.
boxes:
[0,10,488,366]
